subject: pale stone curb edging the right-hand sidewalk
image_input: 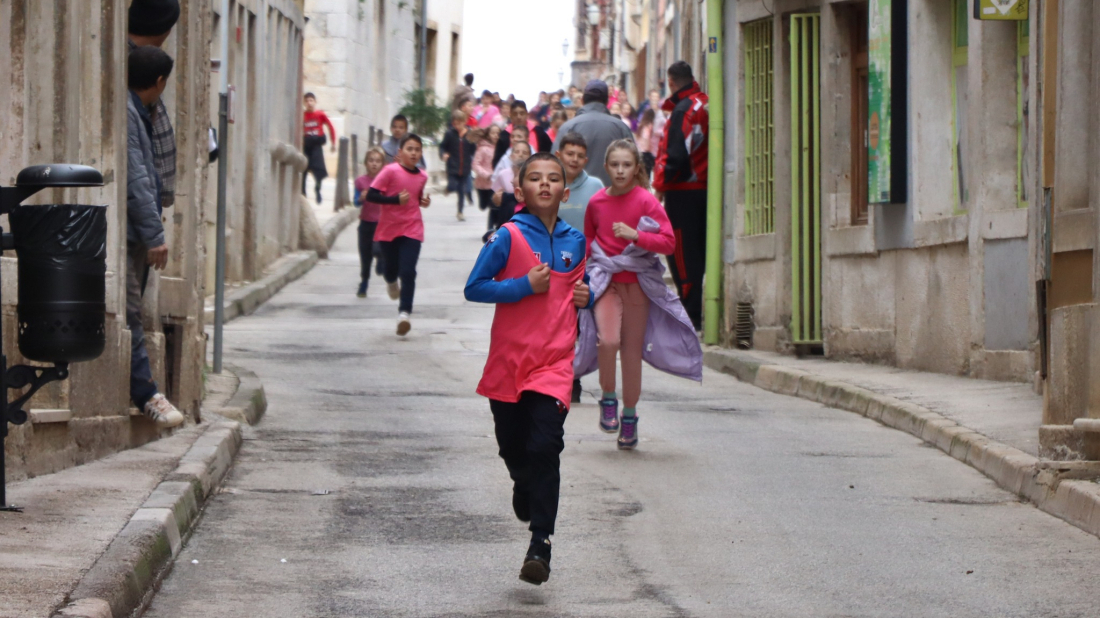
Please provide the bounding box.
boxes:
[703,347,1100,537]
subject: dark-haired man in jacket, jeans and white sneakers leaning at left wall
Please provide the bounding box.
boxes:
[127,45,184,428]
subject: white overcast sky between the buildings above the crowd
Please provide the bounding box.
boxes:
[459,0,576,108]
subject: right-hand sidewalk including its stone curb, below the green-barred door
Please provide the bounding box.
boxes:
[704,346,1100,536]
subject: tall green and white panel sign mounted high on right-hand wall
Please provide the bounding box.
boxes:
[867,0,909,203]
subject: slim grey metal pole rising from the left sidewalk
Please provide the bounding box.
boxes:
[213,0,229,374]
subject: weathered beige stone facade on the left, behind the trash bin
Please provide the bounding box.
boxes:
[0,0,304,479]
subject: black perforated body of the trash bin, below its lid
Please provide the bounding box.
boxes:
[9,203,107,363]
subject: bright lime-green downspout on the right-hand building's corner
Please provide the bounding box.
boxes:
[703,0,726,345]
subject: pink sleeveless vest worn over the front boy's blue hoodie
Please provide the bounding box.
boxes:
[477,223,584,409]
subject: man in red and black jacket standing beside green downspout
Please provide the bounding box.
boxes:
[653,60,711,330]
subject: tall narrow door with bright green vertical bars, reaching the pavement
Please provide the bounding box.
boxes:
[791,13,822,344]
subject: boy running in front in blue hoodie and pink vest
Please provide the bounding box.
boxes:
[465,153,591,585]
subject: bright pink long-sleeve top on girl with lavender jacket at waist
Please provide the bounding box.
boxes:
[584,187,677,284]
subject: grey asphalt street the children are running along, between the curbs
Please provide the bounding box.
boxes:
[145,196,1100,618]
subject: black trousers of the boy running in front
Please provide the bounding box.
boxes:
[488,390,569,536]
